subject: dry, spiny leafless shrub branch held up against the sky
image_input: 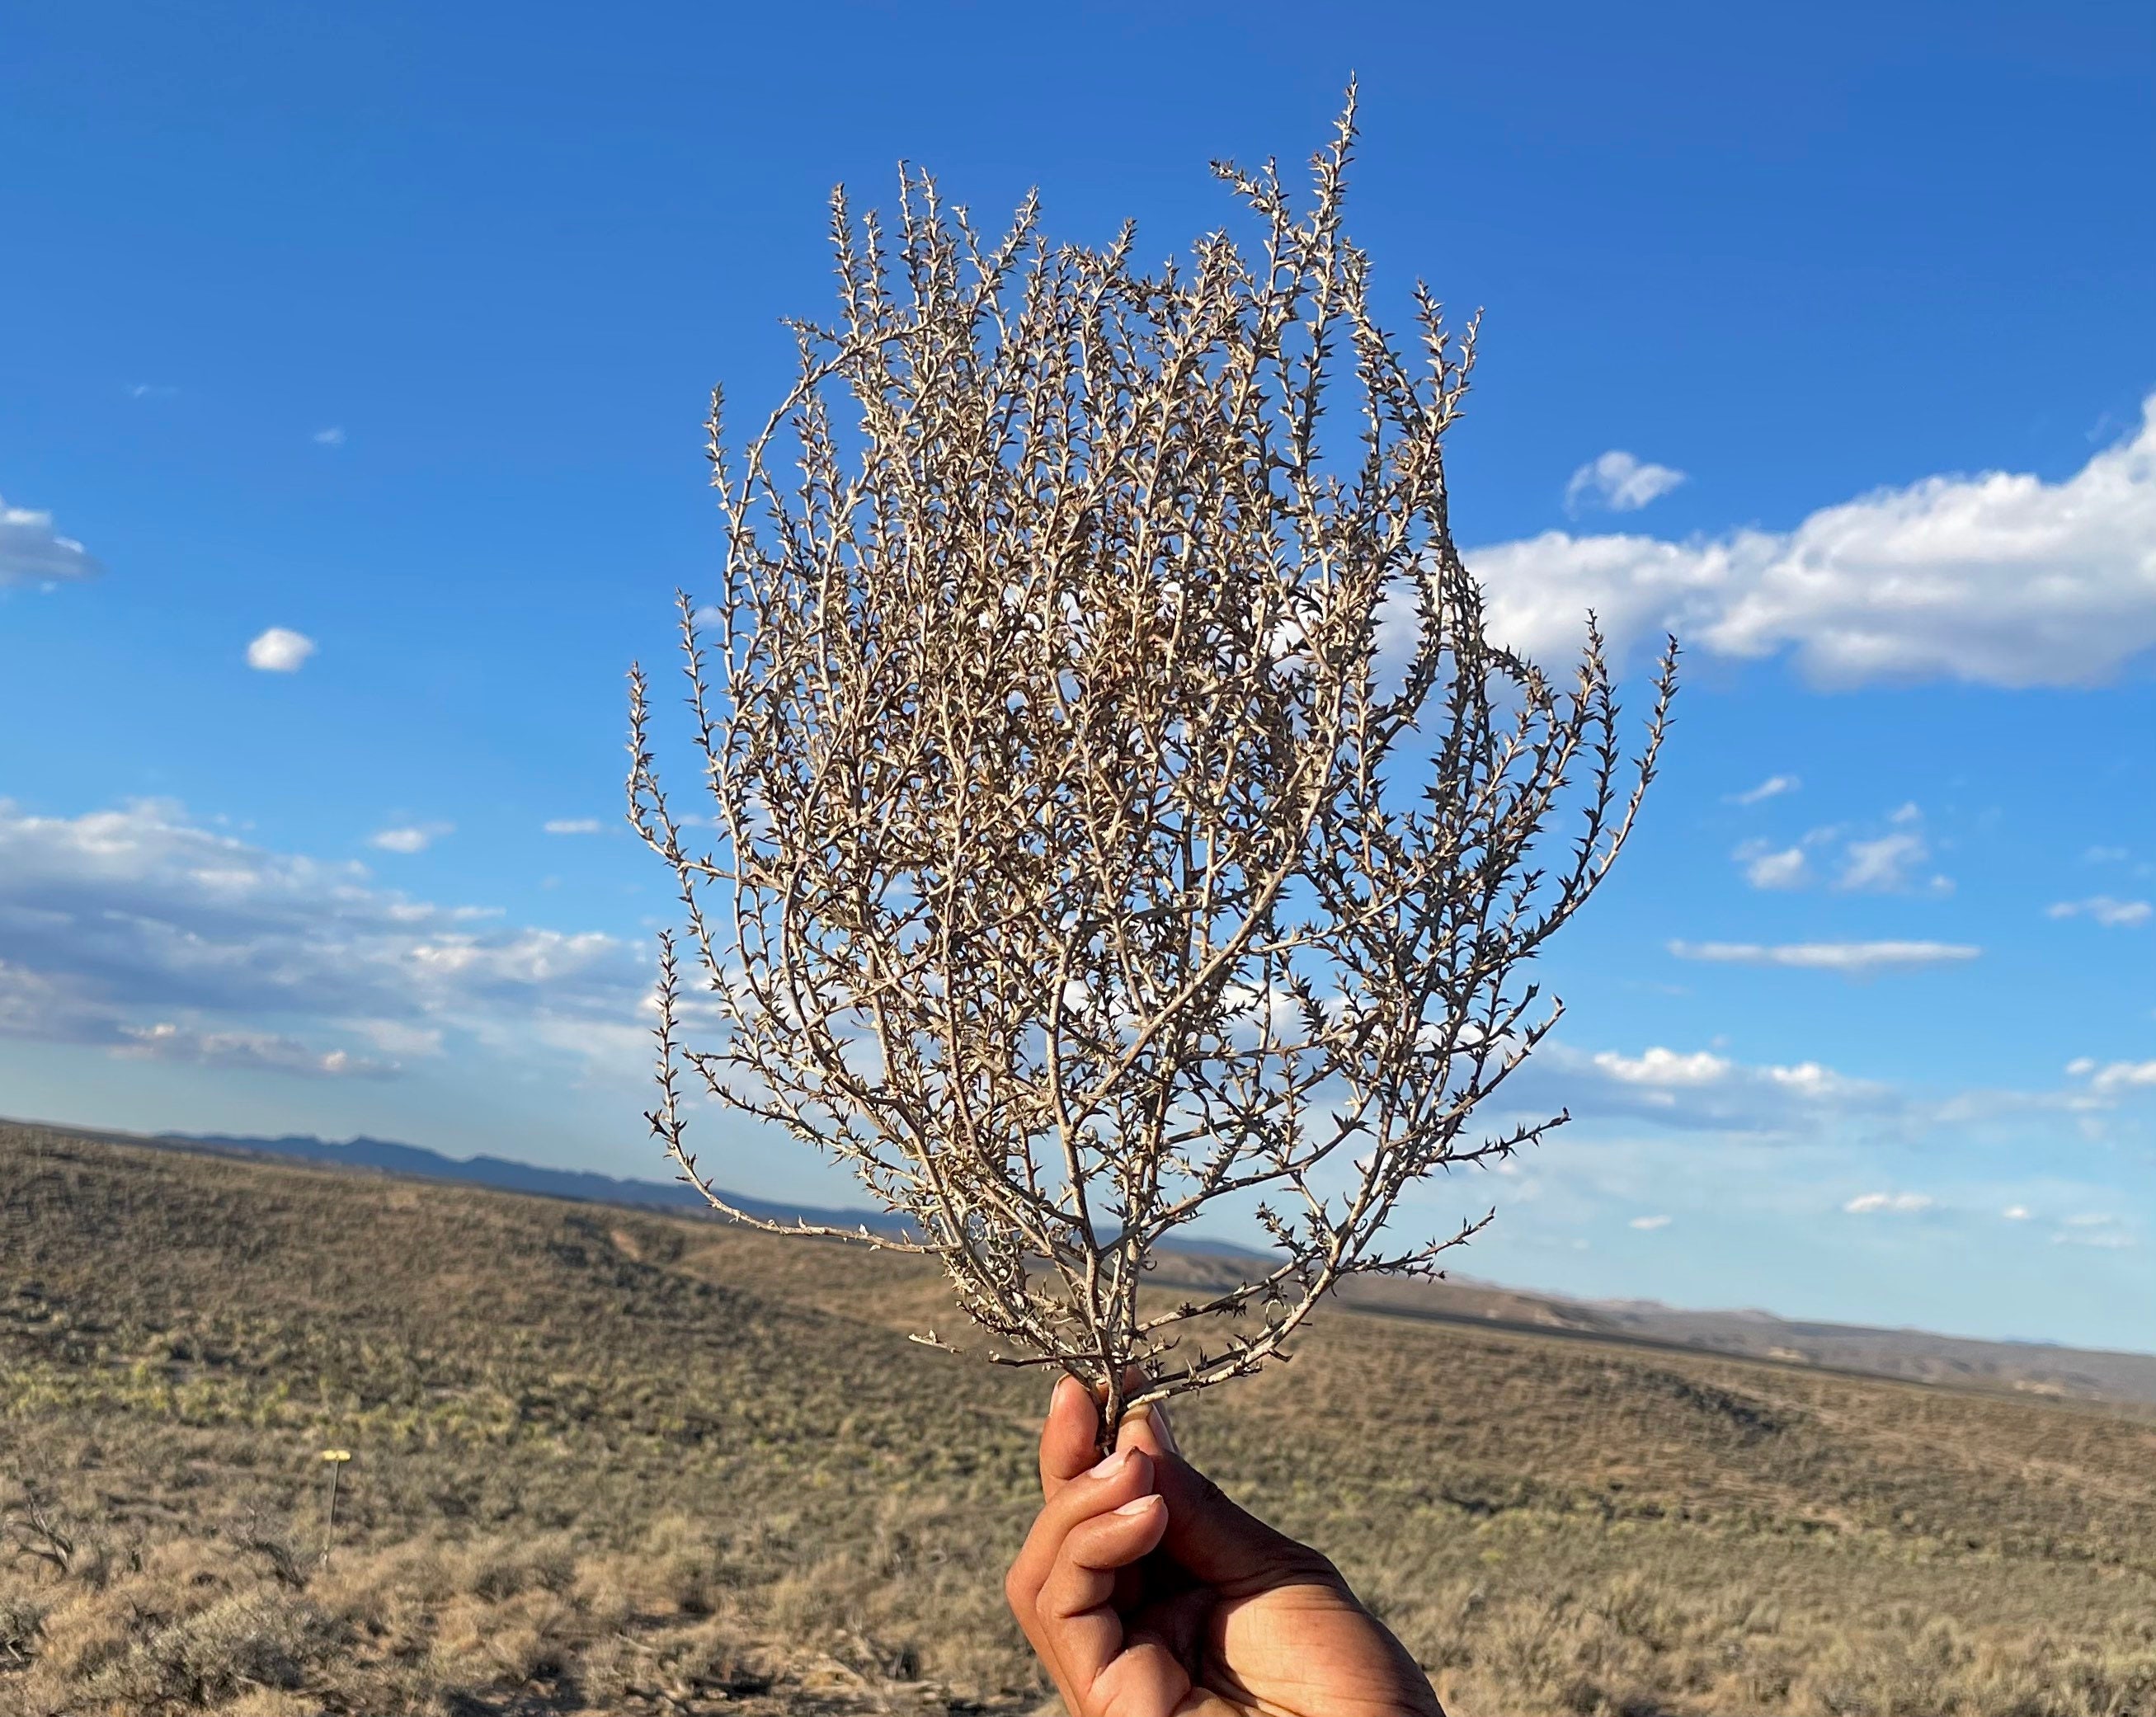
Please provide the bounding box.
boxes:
[629,99,1675,1426]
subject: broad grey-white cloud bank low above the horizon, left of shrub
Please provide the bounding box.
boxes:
[0,800,649,1076]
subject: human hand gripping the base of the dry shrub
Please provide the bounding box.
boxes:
[1003,1378,1444,1717]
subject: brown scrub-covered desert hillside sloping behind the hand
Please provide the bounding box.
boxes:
[0,1128,2156,1717]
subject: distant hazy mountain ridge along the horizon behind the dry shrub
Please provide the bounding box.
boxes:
[21,1128,2156,1404]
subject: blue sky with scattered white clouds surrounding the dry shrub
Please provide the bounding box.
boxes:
[0,0,2156,1348]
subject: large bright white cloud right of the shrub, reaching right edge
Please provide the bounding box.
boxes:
[1466,395,2156,686]
